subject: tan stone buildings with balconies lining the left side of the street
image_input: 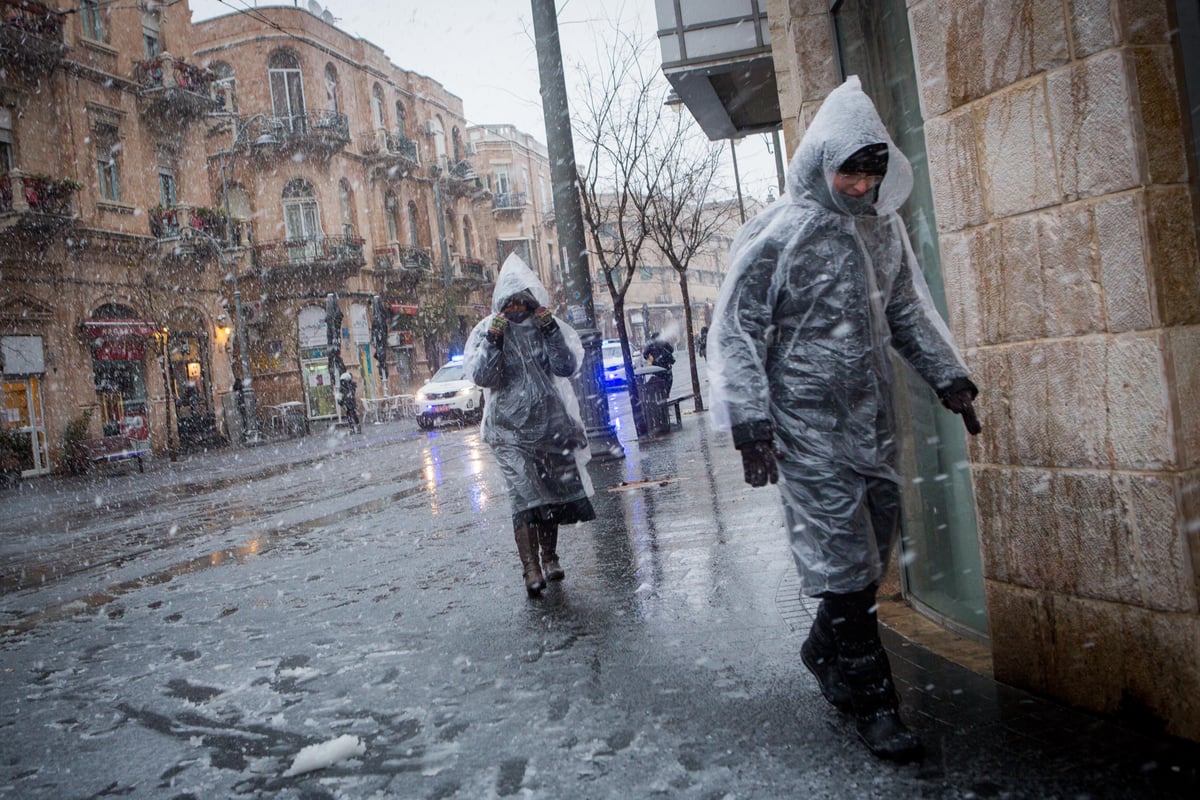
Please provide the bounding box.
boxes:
[0,0,497,475]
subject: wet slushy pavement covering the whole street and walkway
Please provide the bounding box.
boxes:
[0,375,1200,800]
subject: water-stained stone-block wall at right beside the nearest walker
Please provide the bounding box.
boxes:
[767,0,1200,739]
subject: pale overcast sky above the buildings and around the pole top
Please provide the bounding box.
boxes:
[190,0,775,199]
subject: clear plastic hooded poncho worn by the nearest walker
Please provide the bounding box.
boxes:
[707,77,967,594]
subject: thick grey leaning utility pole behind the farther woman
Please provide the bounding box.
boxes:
[532,0,625,458]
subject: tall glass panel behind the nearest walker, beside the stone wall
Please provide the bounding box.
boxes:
[833,0,988,637]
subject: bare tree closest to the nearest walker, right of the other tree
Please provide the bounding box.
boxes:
[646,125,737,411]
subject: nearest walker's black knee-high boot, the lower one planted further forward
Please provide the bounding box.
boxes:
[826,587,922,762]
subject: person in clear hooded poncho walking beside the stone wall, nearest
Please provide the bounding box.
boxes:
[708,77,979,760]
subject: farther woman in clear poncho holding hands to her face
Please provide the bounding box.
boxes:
[463,254,595,595]
